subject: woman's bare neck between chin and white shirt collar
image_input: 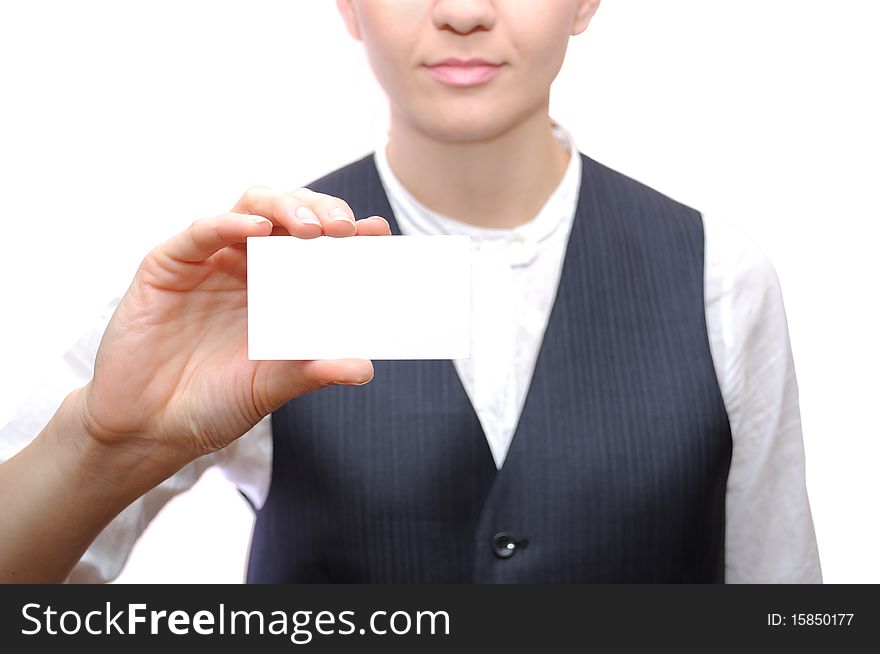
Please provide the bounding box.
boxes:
[385,105,569,229]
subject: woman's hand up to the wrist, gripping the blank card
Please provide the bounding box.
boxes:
[79,187,391,468]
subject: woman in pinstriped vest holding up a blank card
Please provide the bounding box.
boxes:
[0,0,821,582]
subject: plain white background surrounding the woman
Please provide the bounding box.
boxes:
[0,0,880,583]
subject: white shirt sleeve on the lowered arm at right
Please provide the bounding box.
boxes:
[704,215,822,583]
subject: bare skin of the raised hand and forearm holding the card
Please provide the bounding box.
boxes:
[0,188,391,583]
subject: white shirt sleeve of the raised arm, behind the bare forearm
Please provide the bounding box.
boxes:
[0,295,272,583]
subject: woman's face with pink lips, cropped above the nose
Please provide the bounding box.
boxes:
[337,0,599,142]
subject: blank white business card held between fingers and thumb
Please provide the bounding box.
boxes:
[247,235,471,360]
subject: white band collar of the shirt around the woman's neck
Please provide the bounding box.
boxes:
[374,119,581,248]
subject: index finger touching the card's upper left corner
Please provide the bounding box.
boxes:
[152,213,272,263]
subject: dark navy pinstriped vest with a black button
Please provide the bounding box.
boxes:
[247,154,731,583]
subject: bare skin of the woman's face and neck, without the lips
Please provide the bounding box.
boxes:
[336,0,599,228]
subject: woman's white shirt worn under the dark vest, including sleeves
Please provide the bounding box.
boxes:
[0,123,822,583]
